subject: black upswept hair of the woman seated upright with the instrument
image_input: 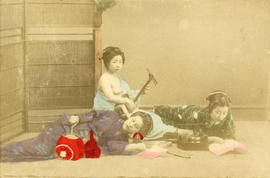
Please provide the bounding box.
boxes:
[102,46,125,69]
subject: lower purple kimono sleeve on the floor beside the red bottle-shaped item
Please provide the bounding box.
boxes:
[102,140,128,155]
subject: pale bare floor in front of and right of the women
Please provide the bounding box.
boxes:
[0,121,270,177]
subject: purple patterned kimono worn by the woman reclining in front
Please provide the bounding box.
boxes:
[0,111,128,162]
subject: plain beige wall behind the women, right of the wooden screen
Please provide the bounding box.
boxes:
[102,0,270,119]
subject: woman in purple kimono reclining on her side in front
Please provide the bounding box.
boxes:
[0,110,152,162]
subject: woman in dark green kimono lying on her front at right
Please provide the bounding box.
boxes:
[154,91,235,142]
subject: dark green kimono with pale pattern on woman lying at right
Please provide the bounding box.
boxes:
[154,105,235,138]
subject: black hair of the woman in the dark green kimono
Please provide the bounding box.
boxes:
[206,90,231,113]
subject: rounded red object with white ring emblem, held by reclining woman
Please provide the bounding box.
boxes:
[56,136,85,161]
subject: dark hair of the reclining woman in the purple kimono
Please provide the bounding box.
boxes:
[131,111,153,137]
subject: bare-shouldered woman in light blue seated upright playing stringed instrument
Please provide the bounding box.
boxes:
[93,46,139,110]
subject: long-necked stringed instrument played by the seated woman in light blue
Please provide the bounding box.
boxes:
[114,69,157,119]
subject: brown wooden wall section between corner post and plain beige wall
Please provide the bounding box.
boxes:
[22,0,96,131]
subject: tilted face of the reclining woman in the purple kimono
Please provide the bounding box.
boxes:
[122,116,143,133]
